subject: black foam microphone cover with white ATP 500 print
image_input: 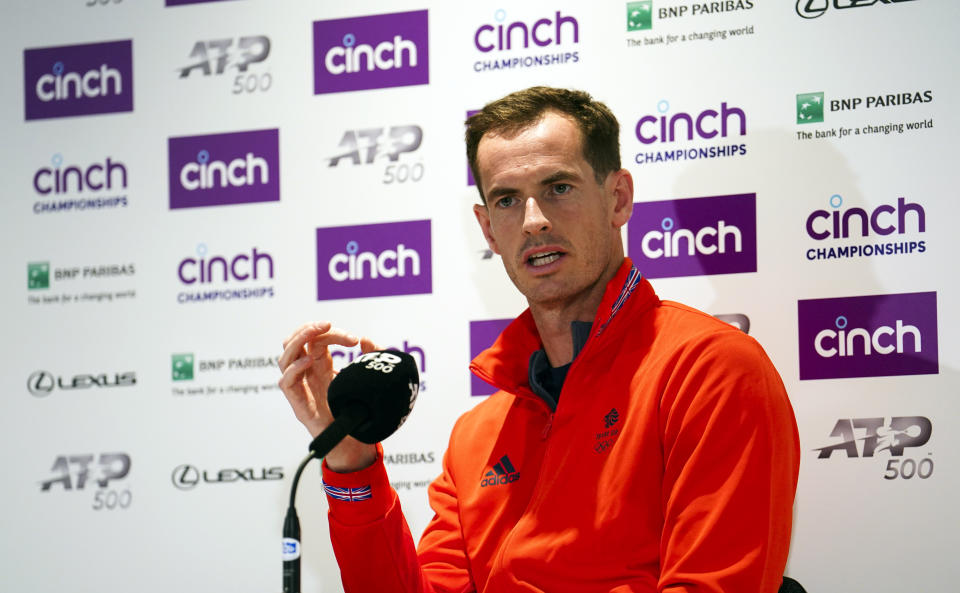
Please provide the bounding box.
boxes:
[327,350,420,445]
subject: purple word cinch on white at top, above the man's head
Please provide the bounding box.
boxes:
[473,8,580,53]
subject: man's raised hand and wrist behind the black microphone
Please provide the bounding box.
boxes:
[278,321,378,473]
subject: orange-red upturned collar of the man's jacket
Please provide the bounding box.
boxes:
[470,258,658,399]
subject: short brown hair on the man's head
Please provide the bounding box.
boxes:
[466,86,620,203]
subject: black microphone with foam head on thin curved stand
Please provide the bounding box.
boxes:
[283,350,420,593]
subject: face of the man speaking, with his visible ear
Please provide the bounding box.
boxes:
[474,111,633,306]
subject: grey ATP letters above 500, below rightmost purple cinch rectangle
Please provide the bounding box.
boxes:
[814,416,933,458]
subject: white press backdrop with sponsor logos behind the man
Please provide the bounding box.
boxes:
[0,0,960,593]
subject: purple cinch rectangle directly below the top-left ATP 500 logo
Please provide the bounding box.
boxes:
[168,129,280,210]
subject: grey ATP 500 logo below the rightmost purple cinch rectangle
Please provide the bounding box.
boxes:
[814,416,933,480]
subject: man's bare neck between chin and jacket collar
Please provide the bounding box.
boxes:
[529,257,623,367]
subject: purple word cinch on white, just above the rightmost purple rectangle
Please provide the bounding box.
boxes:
[807,194,927,241]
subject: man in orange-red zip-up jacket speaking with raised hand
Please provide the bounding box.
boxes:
[280,87,799,593]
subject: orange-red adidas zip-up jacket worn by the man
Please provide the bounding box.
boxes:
[323,259,800,593]
